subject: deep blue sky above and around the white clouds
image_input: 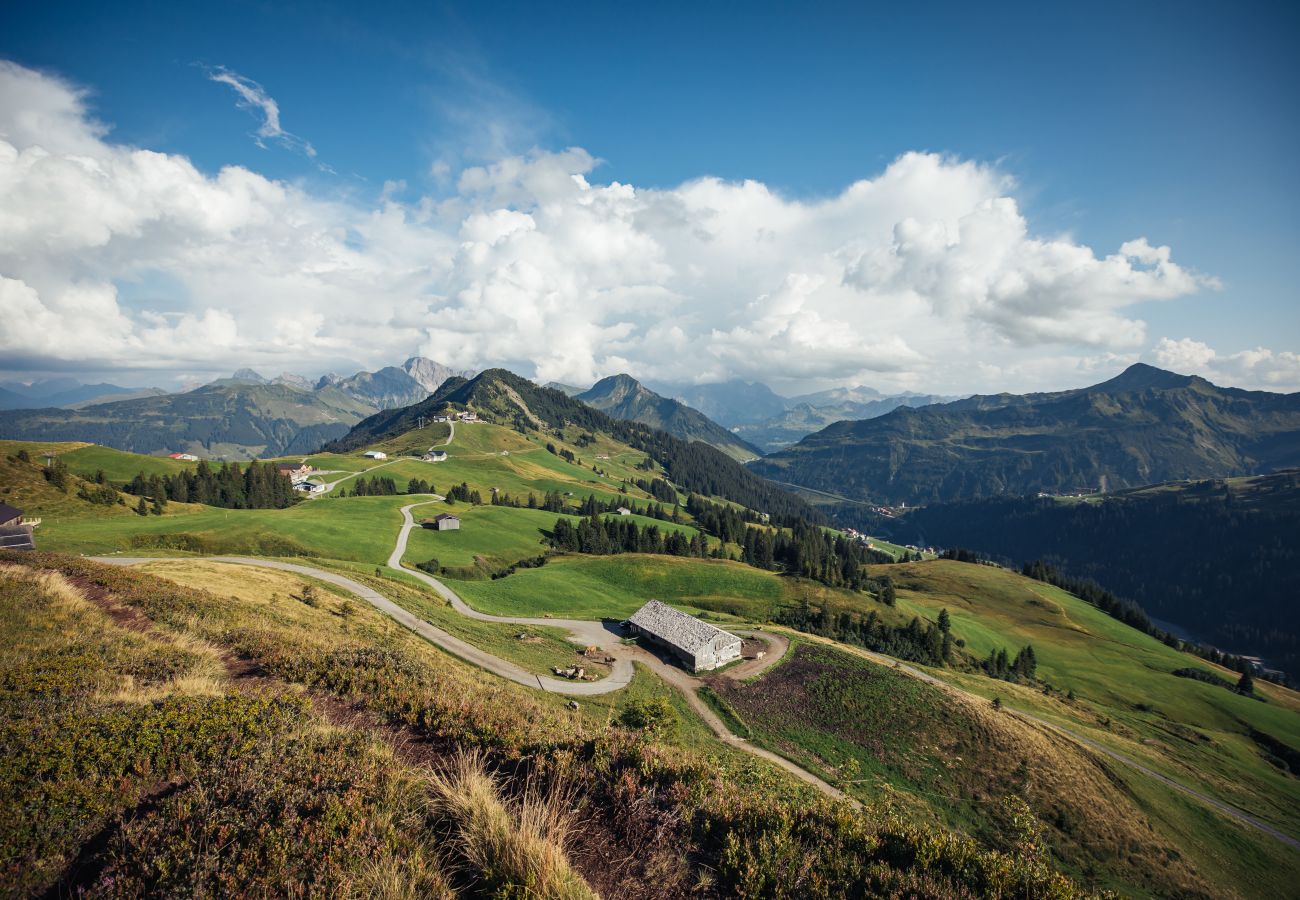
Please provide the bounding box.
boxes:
[0,3,1300,389]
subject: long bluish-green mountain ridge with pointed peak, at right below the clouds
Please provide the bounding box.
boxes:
[754,363,1300,505]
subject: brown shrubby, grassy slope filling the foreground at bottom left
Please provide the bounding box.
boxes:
[0,554,1097,897]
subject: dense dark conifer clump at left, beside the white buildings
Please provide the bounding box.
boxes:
[126,460,298,510]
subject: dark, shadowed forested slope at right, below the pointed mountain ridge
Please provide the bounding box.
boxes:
[891,470,1300,674]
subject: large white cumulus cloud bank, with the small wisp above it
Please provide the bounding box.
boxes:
[0,62,1279,393]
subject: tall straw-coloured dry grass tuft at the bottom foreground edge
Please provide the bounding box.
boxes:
[428,750,597,900]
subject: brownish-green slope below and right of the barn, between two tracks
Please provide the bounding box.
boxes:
[710,642,1227,896]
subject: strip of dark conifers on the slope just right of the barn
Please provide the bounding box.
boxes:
[774,601,959,666]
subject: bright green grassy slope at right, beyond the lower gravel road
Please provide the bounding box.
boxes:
[881,561,1300,853]
